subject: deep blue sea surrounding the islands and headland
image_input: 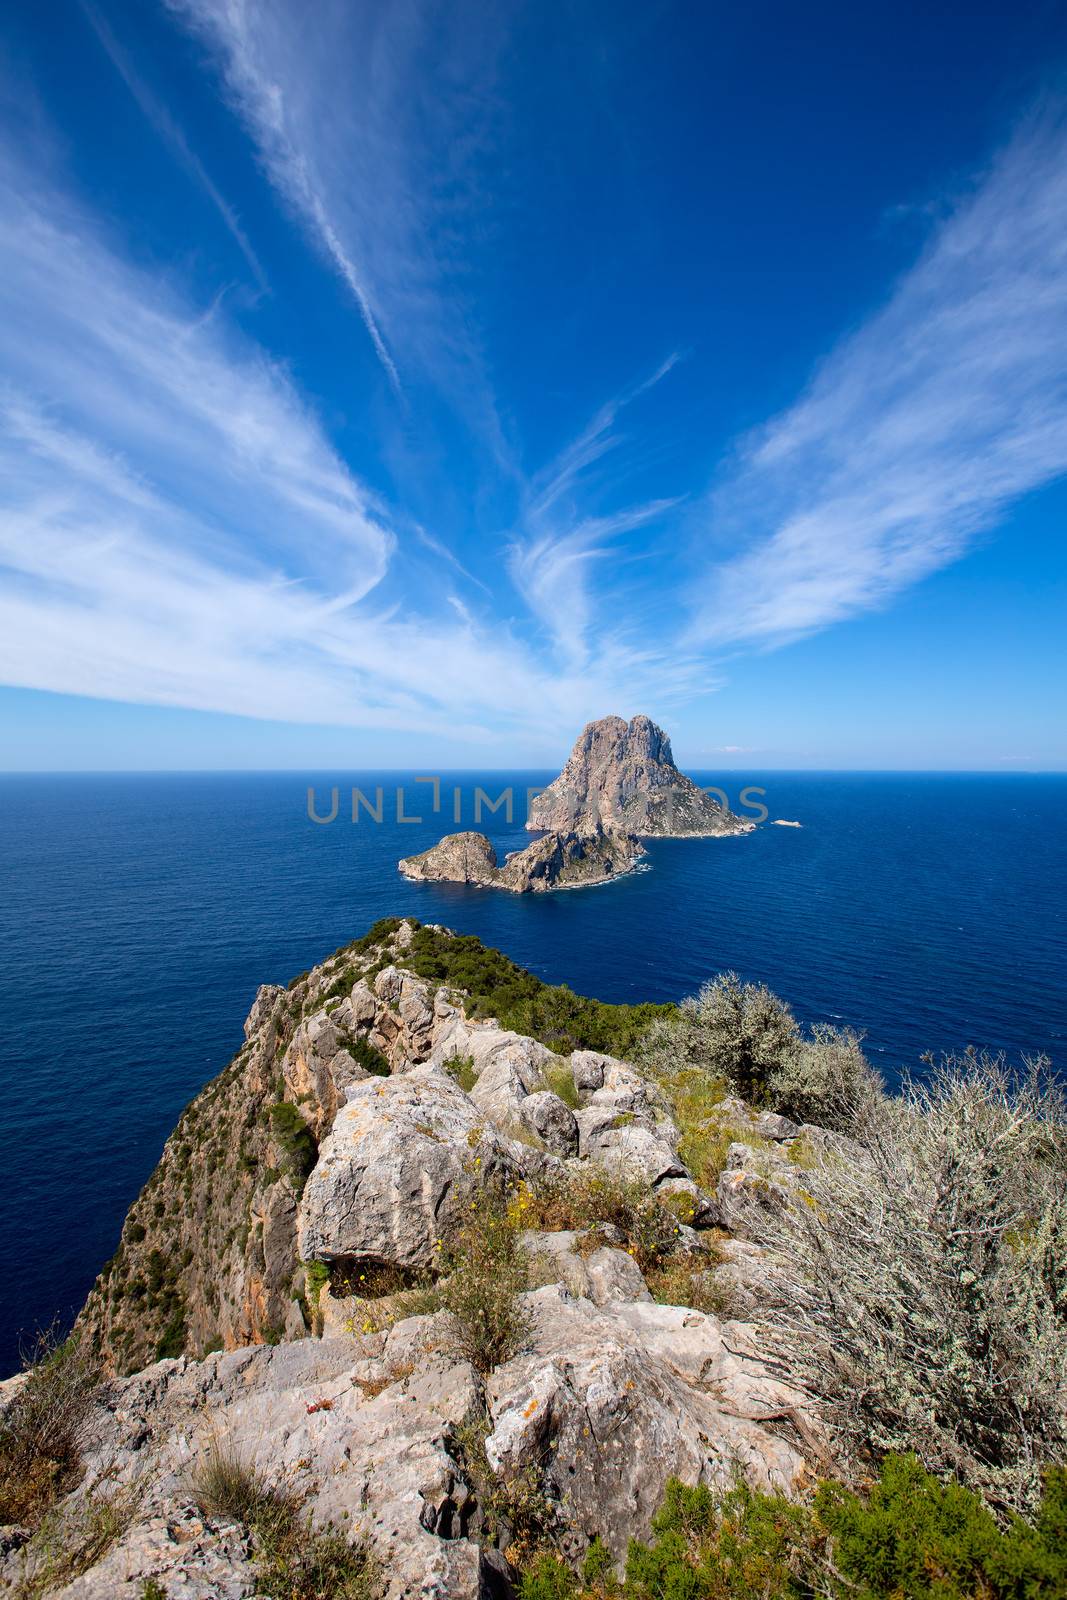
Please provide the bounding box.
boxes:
[0,773,1067,1373]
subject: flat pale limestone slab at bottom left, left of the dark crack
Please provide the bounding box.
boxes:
[29,1337,485,1600]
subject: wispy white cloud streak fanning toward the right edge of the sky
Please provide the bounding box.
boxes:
[689,117,1067,648]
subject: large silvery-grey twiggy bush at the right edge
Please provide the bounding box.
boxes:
[752,1053,1067,1512]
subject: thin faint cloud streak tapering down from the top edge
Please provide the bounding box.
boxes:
[165,0,510,398]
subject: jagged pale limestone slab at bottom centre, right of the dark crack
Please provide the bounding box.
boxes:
[486,1286,805,1562]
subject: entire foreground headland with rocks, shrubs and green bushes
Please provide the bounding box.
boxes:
[0,915,1067,1600]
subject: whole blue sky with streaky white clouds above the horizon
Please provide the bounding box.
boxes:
[0,0,1067,771]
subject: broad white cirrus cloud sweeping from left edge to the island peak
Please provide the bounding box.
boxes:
[0,136,697,741]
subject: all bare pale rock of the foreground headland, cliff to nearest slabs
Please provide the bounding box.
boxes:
[8,922,825,1600]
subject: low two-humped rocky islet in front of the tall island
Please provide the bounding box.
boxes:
[397,826,645,894]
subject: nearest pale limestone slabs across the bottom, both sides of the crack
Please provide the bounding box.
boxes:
[0,1280,817,1600]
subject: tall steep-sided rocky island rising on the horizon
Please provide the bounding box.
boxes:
[526,717,753,838]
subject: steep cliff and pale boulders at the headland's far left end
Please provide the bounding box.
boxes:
[73,922,684,1371]
